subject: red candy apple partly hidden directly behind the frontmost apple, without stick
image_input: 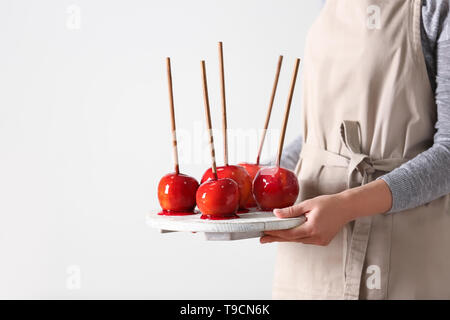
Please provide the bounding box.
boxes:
[201,165,252,209]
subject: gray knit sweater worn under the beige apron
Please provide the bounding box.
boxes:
[281,0,450,213]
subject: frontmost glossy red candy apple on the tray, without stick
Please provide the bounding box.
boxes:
[196,178,239,219]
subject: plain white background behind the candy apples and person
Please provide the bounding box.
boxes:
[0,0,321,299]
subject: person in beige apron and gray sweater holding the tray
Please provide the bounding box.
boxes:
[261,0,450,299]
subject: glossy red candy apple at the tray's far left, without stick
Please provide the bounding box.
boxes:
[158,173,199,214]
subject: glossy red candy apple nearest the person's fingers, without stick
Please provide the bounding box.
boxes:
[253,167,299,210]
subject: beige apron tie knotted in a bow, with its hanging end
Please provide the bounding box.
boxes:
[300,120,408,299]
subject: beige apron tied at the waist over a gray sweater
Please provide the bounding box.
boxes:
[273,0,450,299]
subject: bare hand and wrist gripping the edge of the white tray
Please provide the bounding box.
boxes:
[260,180,392,246]
